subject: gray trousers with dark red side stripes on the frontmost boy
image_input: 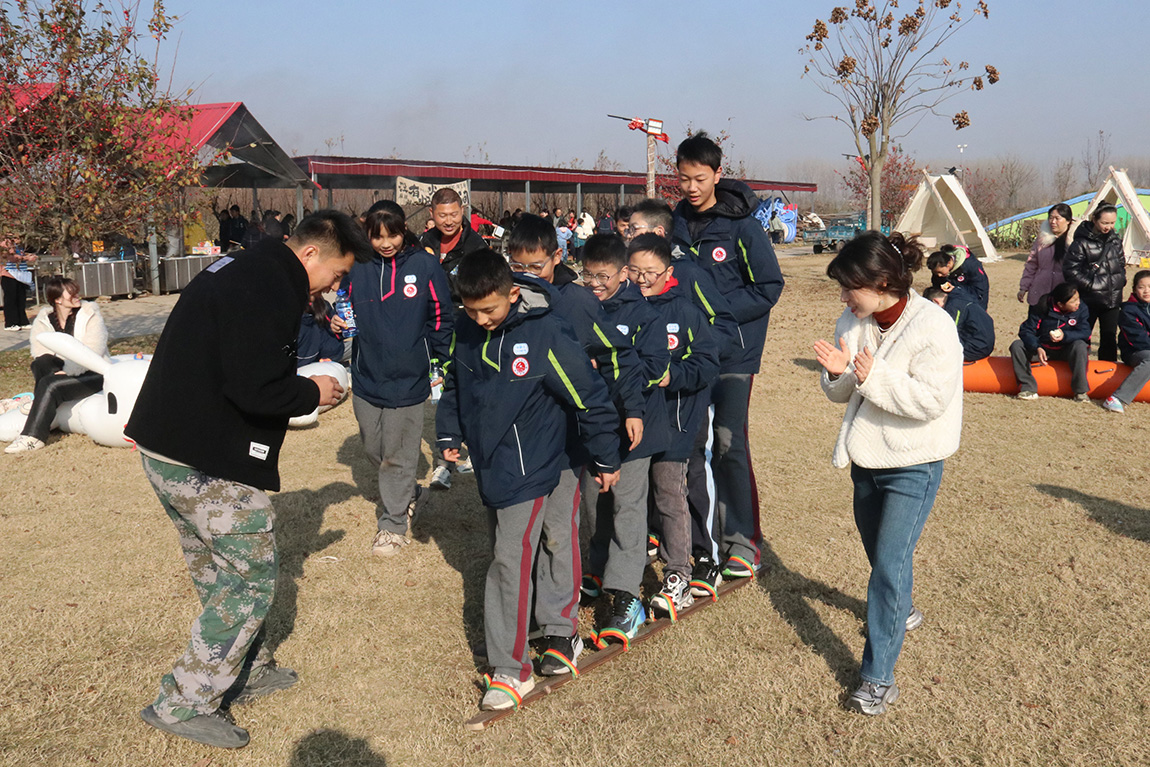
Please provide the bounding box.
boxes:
[483,469,583,681]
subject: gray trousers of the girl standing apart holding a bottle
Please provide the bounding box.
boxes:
[352,396,423,535]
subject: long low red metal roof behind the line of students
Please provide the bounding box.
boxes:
[294,155,819,192]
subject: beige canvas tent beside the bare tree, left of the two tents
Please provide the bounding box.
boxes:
[895,170,998,261]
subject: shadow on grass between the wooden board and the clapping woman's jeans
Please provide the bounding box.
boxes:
[758,542,866,691]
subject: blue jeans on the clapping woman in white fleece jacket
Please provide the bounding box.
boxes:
[851,461,943,684]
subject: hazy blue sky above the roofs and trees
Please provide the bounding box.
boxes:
[162,0,1150,178]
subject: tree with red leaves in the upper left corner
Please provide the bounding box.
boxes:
[0,0,202,253]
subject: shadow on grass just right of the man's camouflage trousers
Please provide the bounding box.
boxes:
[263,482,355,653]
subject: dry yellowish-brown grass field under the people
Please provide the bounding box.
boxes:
[0,256,1150,767]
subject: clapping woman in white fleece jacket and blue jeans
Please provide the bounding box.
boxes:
[814,231,963,715]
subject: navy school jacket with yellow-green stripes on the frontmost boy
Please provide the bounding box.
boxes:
[436,275,619,508]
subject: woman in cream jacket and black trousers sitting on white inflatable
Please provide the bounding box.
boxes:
[3,275,110,453]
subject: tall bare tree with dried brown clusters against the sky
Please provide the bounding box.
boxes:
[803,0,999,227]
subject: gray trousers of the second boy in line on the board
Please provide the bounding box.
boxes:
[583,458,651,596]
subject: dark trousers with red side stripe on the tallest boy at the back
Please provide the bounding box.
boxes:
[714,373,762,567]
